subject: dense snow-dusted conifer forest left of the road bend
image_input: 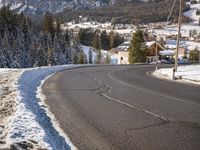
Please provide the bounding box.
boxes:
[0,7,81,68]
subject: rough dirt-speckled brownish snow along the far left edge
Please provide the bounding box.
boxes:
[0,69,21,149]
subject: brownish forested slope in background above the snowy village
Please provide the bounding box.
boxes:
[59,0,189,24]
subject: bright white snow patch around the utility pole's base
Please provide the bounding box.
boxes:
[153,65,200,84]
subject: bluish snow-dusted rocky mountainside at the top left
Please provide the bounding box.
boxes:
[0,0,115,14]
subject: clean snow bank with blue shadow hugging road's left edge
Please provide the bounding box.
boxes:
[8,66,75,150]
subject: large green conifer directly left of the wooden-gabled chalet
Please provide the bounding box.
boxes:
[128,30,147,64]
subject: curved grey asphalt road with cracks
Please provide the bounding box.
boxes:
[43,65,200,150]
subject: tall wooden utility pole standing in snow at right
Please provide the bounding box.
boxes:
[173,0,183,72]
